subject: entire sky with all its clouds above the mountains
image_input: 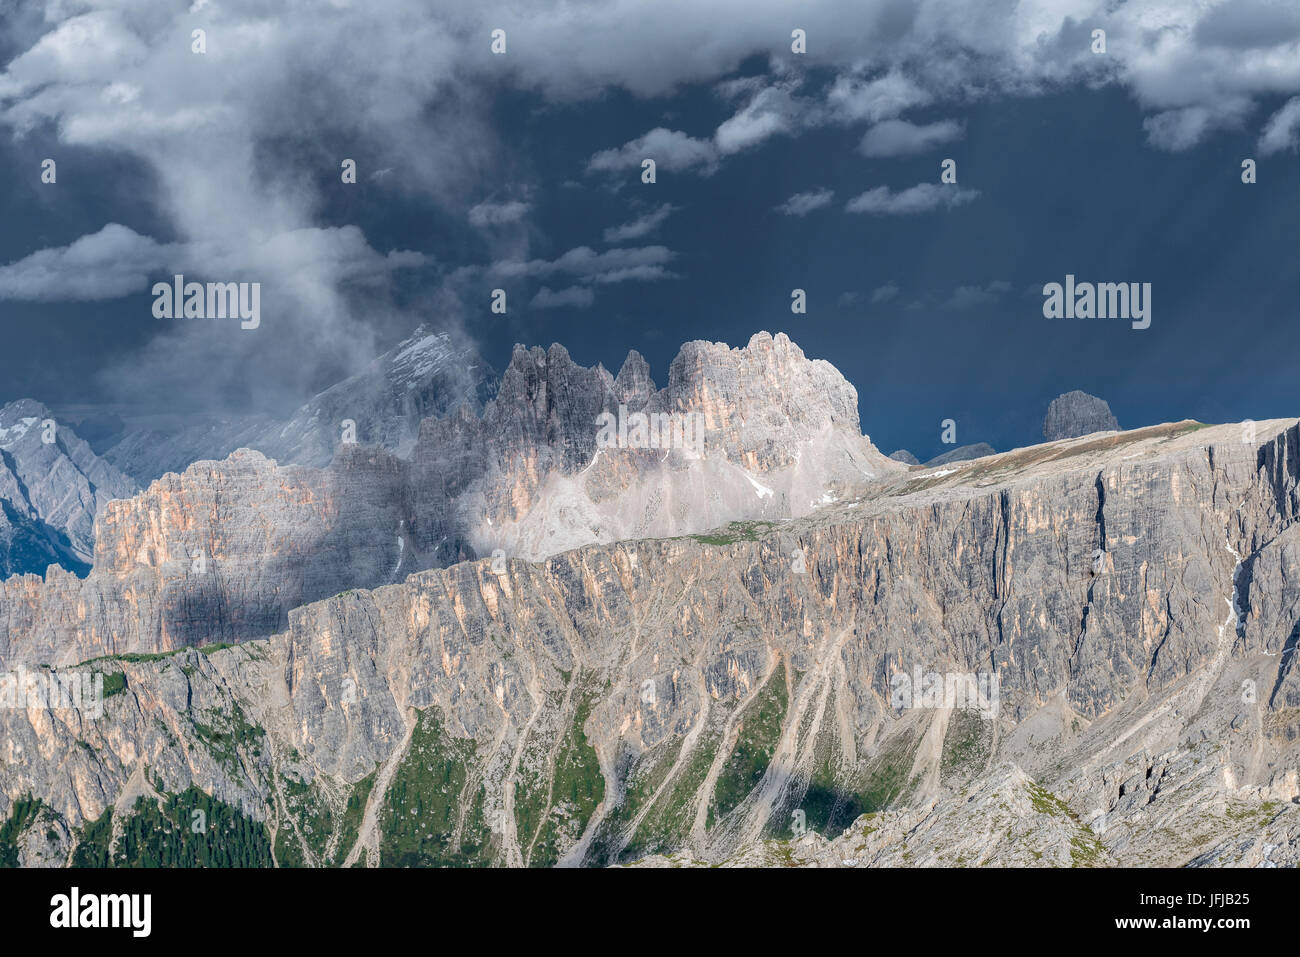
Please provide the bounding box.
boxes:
[0,0,1300,459]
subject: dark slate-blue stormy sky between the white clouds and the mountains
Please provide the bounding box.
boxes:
[0,1,1300,459]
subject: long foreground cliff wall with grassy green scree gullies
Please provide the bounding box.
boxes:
[0,416,1300,865]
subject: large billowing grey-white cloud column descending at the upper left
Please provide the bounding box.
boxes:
[0,0,498,410]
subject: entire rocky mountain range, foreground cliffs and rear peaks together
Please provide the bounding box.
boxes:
[0,332,1300,866]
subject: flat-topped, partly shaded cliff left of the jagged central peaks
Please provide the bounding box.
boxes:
[0,446,415,668]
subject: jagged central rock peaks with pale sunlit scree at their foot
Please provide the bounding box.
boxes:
[413,333,904,559]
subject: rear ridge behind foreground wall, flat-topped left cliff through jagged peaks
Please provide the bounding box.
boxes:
[0,333,902,667]
